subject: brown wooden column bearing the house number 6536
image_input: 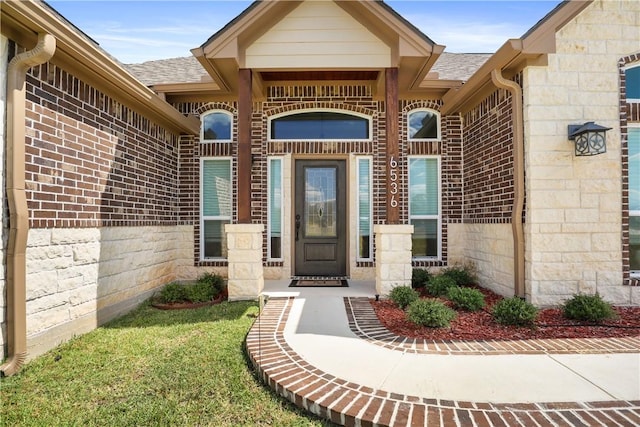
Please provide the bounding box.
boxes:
[385,68,401,224]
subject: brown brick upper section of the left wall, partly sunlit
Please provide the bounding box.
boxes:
[25,63,178,228]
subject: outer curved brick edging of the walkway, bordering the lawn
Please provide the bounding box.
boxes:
[246,297,640,427]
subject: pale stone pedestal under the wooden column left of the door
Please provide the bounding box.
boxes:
[224,224,264,301]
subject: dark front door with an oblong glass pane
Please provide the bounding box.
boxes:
[294,160,347,276]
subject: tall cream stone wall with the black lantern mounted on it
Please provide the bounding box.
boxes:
[523,0,640,305]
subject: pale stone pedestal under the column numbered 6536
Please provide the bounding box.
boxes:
[373,224,413,295]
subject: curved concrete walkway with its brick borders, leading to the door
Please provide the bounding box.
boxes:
[247,281,640,426]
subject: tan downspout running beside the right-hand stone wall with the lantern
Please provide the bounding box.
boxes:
[491,68,526,298]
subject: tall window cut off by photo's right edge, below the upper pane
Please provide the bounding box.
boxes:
[629,126,640,277]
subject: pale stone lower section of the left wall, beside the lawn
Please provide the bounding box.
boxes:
[27,225,193,358]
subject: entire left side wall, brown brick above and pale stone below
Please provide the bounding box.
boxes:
[2,52,193,358]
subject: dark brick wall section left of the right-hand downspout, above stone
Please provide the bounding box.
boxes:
[463,85,514,223]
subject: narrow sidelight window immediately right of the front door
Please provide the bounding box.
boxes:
[356,157,373,261]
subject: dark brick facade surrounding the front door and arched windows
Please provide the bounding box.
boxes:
[175,85,462,266]
